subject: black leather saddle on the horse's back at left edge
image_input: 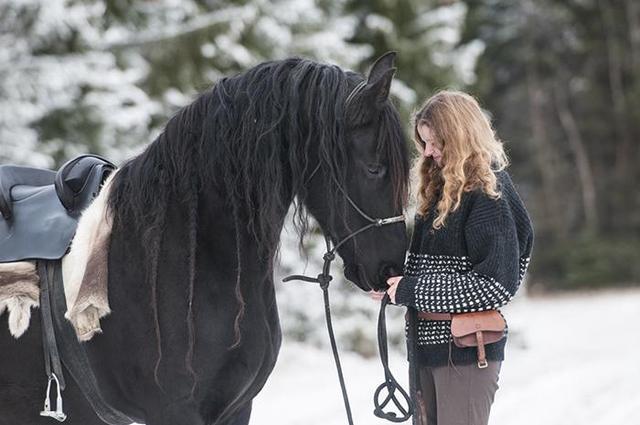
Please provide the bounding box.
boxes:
[0,155,116,263]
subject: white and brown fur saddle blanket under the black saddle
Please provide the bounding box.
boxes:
[0,173,115,341]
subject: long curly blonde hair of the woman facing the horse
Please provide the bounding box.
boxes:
[412,90,509,229]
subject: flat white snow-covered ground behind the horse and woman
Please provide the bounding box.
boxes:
[251,289,640,425]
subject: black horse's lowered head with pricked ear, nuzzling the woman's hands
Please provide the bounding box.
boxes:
[305,53,409,290]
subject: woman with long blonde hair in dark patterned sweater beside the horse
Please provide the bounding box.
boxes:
[380,91,533,425]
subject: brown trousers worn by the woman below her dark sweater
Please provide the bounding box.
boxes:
[416,361,502,425]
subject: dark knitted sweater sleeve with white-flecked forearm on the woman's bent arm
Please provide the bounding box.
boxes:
[396,195,528,313]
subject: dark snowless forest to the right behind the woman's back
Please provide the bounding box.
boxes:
[462,0,640,287]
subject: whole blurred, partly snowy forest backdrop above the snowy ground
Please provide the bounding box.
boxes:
[0,0,640,302]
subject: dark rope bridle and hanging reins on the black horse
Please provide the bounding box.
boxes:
[282,82,414,425]
